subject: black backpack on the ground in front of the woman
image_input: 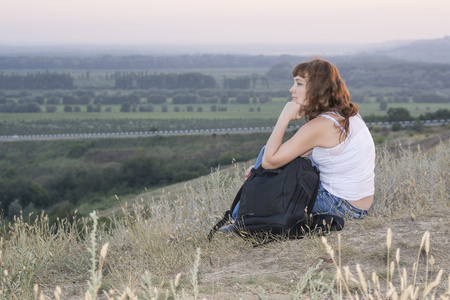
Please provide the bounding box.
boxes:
[208,157,344,241]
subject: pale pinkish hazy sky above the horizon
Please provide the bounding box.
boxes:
[0,0,450,45]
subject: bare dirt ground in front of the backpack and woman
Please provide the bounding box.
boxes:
[199,207,450,299]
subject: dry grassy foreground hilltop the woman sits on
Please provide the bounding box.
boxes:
[0,143,450,299]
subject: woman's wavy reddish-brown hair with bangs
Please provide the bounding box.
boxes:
[292,58,359,138]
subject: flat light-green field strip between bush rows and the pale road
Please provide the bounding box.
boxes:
[0,98,450,136]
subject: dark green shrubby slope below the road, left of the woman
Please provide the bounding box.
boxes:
[0,133,269,221]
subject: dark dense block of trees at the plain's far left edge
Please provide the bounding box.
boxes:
[0,72,74,90]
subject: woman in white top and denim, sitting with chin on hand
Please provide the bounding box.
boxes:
[246,59,375,219]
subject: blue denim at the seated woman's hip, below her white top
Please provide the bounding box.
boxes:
[312,183,369,219]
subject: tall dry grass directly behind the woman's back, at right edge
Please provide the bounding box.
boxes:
[373,143,450,216]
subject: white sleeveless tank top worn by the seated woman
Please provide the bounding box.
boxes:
[311,112,375,201]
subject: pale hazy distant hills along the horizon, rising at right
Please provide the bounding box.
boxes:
[0,36,450,63]
